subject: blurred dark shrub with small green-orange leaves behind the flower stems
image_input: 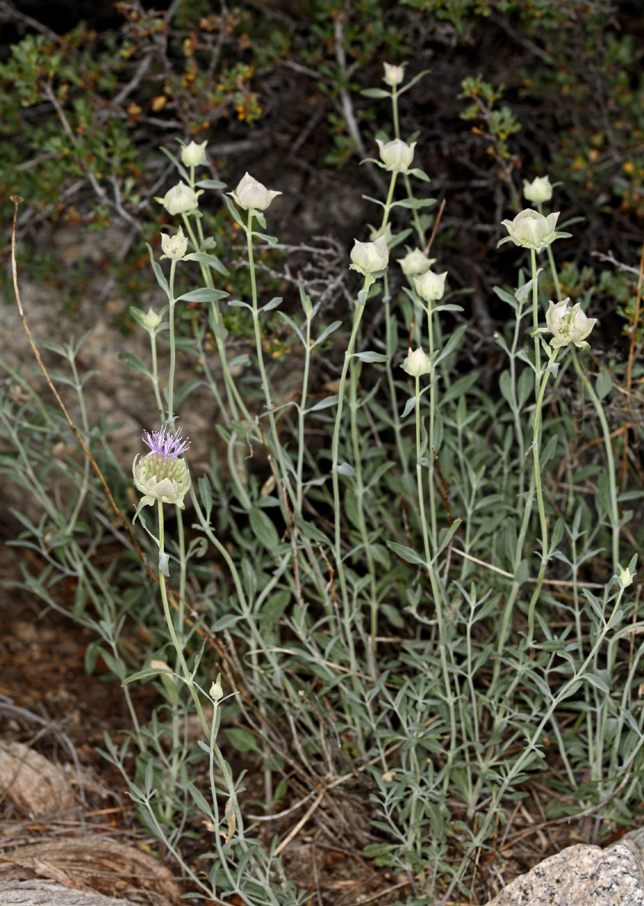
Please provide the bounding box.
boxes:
[0,0,644,333]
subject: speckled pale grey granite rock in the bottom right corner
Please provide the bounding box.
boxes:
[487,830,644,906]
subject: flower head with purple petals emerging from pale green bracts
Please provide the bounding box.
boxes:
[132,425,190,509]
